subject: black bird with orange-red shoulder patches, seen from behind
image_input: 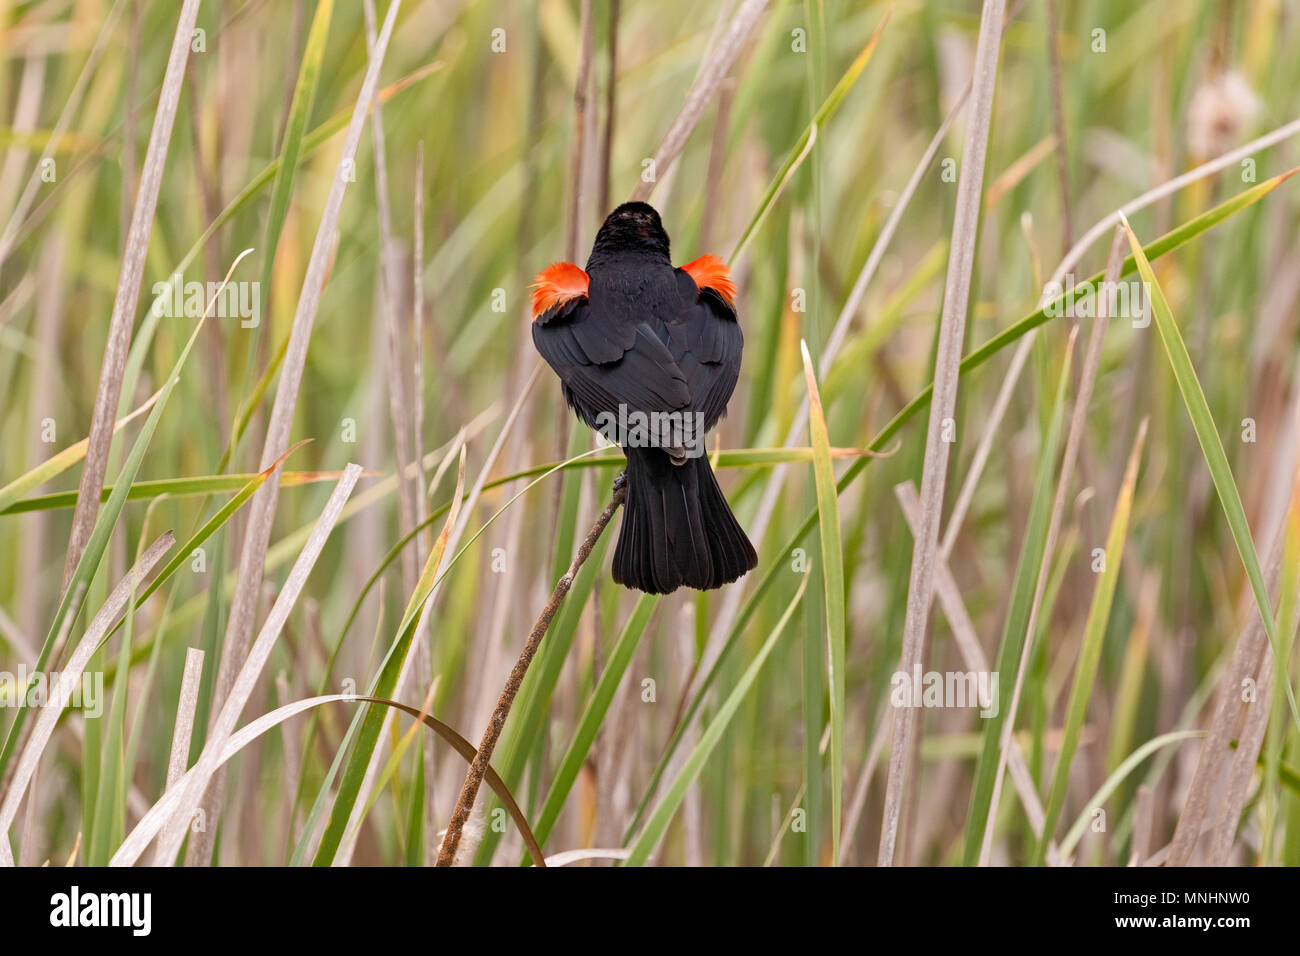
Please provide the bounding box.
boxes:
[533,203,758,594]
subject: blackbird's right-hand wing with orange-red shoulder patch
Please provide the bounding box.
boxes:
[670,256,745,428]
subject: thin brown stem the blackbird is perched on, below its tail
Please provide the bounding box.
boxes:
[436,475,628,866]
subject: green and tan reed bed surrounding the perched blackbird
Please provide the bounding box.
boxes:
[0,0,1300,865]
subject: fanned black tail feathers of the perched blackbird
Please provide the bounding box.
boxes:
[614,449,758,594]
